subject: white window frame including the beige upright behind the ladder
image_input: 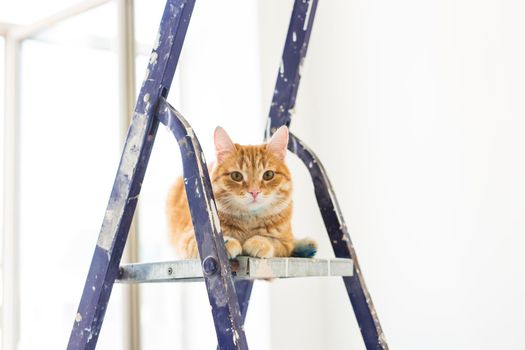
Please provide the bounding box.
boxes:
[0,0,140,350]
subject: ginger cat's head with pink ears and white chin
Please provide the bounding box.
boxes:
[212,127,292,215]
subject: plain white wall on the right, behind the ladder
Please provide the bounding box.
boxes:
[260,0,525,350]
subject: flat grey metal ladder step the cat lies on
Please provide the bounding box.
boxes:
[117,256,354,283]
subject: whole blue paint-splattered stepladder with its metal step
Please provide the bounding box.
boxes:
[68,0,388,350]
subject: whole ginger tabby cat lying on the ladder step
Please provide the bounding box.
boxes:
[166,126,317,259]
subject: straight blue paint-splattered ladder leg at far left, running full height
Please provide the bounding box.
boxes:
[68,0,194,350]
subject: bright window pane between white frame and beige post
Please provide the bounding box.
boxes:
[19,3,122,349]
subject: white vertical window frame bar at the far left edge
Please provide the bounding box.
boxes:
[2,35,20,350]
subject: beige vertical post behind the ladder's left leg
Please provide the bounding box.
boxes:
[117,0,140,350]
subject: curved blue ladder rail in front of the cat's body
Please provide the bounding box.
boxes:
[159,101,248,350]
